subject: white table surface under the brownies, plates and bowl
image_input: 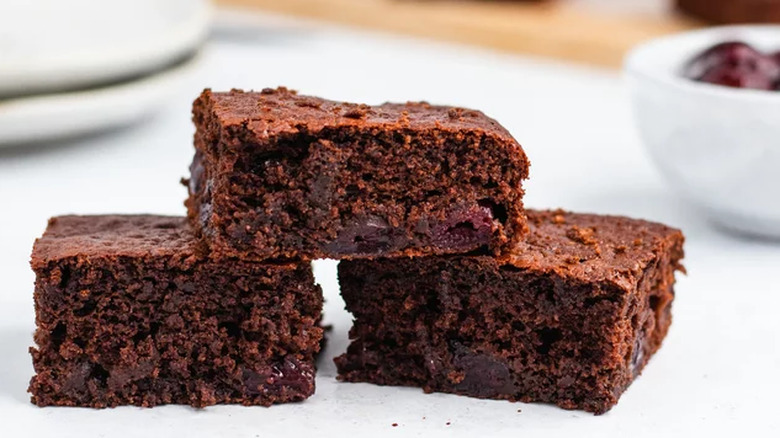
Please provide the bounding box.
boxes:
[0,8,780,437]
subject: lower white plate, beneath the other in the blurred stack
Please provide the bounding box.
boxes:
[0,53,198,148]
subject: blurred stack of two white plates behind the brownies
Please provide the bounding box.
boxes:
[0,0,210,147]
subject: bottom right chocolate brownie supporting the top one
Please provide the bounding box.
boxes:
[335,210,684,414]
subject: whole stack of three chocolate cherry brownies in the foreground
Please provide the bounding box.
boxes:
[25,88,683,413]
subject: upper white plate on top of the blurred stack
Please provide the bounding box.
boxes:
[0,0,210,96]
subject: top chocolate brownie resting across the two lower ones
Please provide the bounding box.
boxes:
[186,88,529,260]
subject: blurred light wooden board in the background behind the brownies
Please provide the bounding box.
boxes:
[218,0,697,67]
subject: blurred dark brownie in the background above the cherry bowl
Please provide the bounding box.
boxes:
[677,0,780,24]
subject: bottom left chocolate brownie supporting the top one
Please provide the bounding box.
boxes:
[29,216,322,408]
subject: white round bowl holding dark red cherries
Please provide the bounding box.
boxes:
[624,26,780,238]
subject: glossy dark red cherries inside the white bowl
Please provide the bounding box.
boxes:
[685,41,780,90]
